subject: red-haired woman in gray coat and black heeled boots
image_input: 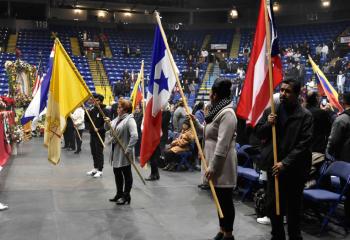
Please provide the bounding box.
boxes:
[105,99,138,205]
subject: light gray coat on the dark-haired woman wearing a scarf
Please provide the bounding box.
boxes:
[196,106,237,188]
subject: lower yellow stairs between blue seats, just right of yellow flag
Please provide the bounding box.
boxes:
[88,59,114,105]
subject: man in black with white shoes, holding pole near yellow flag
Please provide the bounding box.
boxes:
[85,94,109,178]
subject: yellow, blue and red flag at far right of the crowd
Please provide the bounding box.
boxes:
[309,55,343,112]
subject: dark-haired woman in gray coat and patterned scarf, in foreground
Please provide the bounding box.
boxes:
[191,78,237,240]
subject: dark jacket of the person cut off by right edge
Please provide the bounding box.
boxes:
[327,109,350,162]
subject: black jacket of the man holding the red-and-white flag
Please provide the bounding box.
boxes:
[255,104,313,181]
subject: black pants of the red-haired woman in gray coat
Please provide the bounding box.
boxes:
[113,165,132,196]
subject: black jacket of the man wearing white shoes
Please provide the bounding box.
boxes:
[84,104,109,137]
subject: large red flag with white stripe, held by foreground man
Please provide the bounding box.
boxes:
[237,0,283,127]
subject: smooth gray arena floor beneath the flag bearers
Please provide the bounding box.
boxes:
[0,134,350,240]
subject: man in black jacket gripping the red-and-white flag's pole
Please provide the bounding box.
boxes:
[256,80,313,240]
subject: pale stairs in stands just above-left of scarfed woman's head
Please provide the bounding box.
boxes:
[196,63,220,104]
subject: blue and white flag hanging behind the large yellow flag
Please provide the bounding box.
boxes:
[21,48,55,125]
